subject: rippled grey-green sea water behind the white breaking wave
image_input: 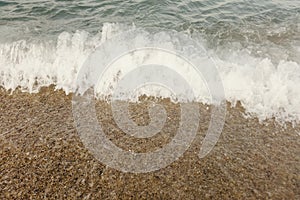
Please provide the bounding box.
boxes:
[0,0,300,60]
